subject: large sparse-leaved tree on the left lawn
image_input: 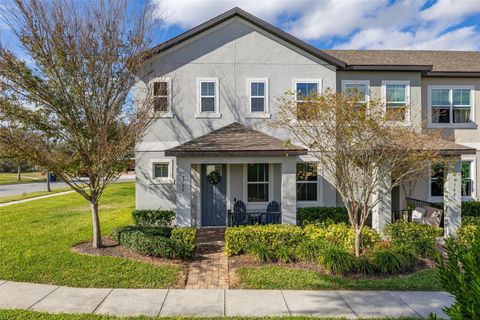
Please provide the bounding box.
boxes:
[0,0,159,247]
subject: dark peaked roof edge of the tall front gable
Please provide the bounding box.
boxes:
[141,7,345,68]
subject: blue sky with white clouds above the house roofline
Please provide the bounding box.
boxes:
[0,0,480,54]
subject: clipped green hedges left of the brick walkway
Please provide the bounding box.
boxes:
[112,210,197,259]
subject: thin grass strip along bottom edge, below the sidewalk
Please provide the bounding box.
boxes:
[0,310,419,320]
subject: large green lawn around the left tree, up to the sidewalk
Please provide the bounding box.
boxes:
[0,183,180,288]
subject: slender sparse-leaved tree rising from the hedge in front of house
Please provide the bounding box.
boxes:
[275,92,448,256]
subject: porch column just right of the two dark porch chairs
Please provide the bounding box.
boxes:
[281,157,297,224]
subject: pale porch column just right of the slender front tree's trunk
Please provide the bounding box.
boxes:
[372,171,392,232]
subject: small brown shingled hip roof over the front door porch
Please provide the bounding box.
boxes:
[165,122,307,157]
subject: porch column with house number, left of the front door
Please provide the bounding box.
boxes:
[175,158,192,227]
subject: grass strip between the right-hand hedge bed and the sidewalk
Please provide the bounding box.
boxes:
[237,266,442,291]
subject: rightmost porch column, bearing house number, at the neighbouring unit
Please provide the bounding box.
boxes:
[443,158,462,237]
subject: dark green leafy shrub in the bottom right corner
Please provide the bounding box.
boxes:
[438,227,480,319]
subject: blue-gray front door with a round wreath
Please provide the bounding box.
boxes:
[200,164,227,226]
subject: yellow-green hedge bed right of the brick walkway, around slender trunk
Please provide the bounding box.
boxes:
[225,223,439,275]
